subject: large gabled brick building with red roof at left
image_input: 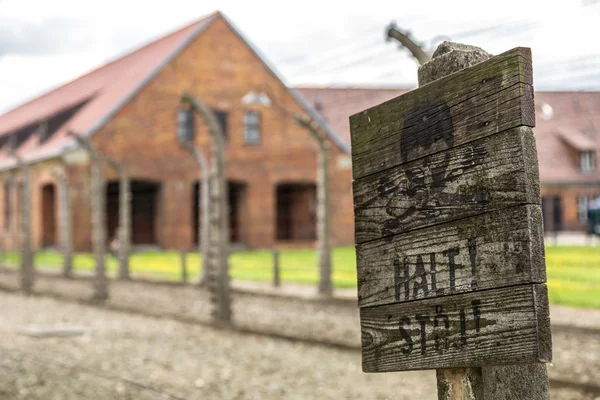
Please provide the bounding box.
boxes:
[0,13,353,250]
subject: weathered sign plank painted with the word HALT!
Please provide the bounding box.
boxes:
[356,205,546,307]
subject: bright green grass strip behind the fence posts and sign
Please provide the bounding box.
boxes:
[5,246,600,309]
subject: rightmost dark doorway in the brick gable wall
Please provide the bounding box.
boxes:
[276,183,317,241]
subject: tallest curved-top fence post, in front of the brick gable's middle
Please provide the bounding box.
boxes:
[182,94,231,326]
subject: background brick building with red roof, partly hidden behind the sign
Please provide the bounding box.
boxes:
[299,87,600,231]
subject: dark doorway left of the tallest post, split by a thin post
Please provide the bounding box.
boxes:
[106,180,160,245]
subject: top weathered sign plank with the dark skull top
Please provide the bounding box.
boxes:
[350,48,535,179]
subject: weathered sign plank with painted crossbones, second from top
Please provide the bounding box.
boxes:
[353,127,541,243]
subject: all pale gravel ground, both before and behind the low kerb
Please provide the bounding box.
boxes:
[0,273,600,400]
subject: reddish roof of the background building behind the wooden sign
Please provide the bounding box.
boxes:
[297,87,600,184]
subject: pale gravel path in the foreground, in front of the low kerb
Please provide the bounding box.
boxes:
[0,293,435,400]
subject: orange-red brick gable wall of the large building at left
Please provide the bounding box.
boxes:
[76,18,353,249]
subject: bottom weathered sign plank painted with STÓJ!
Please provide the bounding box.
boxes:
[360,285,552,372]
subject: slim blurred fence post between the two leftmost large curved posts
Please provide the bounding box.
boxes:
[53,167,73,278]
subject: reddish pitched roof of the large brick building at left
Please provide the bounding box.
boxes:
[0,12,350,169]
